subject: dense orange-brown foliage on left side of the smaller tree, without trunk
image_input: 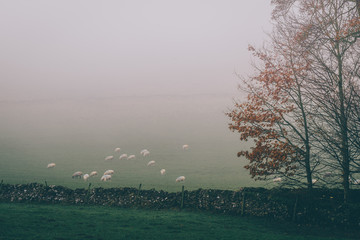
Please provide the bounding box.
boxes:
[227,46,303,179]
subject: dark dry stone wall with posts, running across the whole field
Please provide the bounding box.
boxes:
[0,183,360,227]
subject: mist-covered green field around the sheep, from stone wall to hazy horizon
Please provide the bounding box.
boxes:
[0,95,263,191]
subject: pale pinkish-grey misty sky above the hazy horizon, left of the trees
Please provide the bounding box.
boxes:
[0,0,271,100]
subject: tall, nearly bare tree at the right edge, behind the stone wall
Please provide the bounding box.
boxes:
[272,0,360,202]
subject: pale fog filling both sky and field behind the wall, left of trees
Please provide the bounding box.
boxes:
[0,0,271,191]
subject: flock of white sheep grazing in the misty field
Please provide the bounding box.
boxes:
[47,144,189,182]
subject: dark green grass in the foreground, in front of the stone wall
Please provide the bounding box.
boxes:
[0,203,354,240]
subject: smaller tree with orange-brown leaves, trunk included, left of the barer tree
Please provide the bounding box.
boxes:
[227,44,313,189]
